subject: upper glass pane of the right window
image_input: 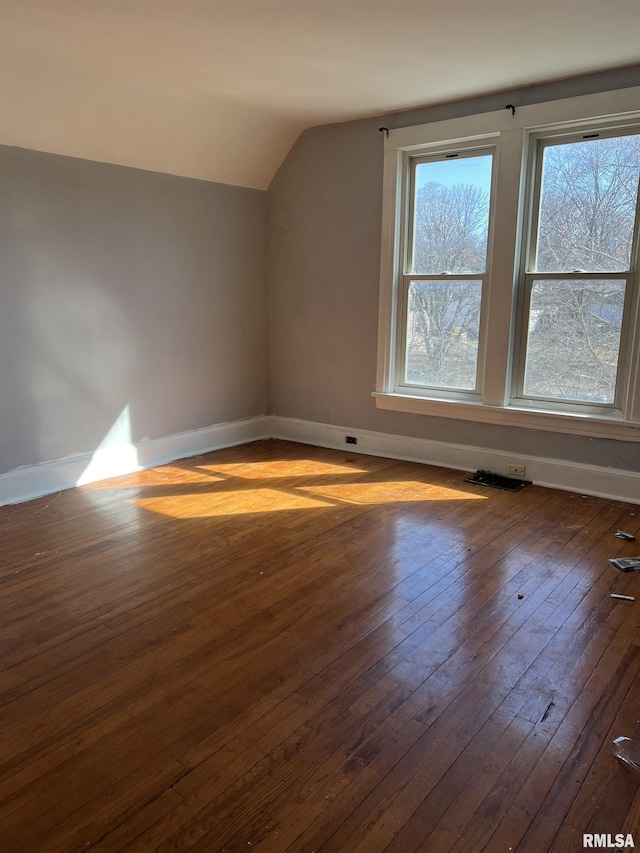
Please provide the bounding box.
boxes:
[536,134,640,272]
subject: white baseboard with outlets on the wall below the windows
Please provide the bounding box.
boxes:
[271,416,640,504]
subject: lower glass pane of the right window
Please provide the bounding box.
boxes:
[524,280,625,403]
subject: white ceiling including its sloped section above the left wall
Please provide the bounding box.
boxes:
[0,0,640,189]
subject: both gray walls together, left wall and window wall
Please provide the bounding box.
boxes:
[0,69,640,480]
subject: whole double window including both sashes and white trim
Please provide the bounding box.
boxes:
[375,89,640,441]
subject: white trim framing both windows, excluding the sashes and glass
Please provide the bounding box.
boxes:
[373,87,640,441]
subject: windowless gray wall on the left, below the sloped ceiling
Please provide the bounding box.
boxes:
[0,147,268,473]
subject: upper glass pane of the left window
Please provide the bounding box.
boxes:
[413,154,493,275]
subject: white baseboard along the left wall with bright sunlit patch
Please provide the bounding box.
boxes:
[0,415,271,506]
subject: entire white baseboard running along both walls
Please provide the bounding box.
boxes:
[0,415,640,506]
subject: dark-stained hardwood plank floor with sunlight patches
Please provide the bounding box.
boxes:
[0,441,640,853]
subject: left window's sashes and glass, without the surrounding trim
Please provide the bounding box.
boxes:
[399,150,493,392]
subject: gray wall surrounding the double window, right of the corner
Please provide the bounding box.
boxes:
[268,67,640,470]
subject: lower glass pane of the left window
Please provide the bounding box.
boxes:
[405,281,482,390]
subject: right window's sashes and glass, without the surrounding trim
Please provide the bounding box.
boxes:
[518,133,640,408]
